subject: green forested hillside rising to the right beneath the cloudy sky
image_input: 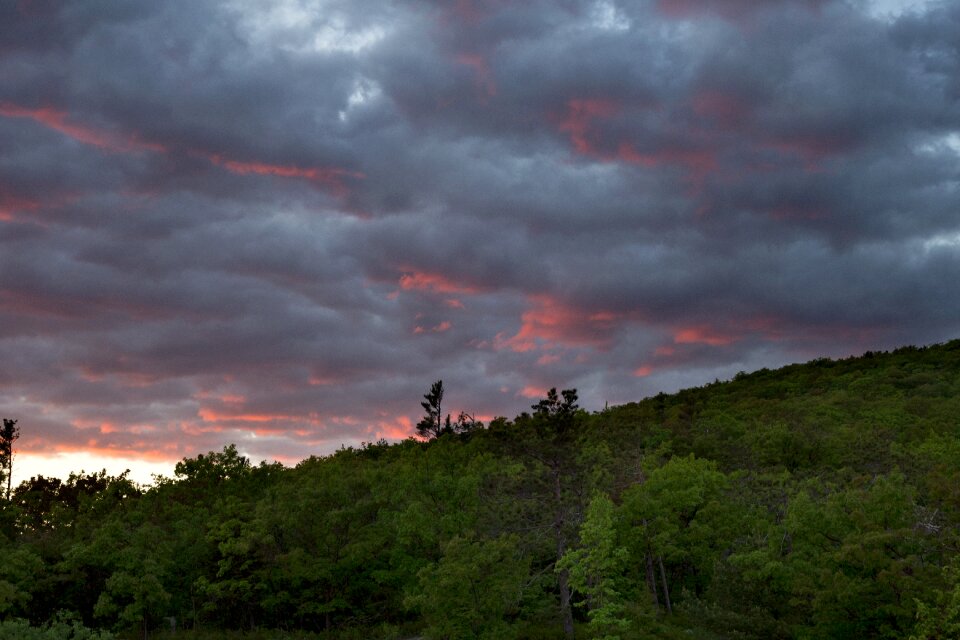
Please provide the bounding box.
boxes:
[0,341,960,640]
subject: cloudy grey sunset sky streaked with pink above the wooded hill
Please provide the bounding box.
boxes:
[0,0,960,482]
